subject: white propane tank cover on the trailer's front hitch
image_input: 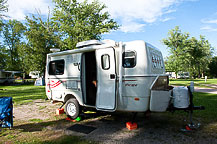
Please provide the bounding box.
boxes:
[173,87,189,108]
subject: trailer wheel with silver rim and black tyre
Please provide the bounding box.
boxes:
[65,98,80,119]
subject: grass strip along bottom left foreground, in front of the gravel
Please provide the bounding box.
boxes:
[0,129,96,144]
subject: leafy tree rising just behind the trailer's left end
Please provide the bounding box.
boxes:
[22,15,60,73]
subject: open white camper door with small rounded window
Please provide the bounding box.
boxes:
[96,48,116,111]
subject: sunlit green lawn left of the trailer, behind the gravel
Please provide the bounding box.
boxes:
[0,85,46,104]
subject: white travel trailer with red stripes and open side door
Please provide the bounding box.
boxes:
[45,40,203,118]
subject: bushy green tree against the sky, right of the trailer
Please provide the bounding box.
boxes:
[162,27,213,77]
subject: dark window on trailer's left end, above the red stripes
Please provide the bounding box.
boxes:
[49,60,65,75]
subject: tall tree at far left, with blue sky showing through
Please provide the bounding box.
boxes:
[2,20,25,70]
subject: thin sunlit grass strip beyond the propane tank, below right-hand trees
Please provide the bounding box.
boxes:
[169,79,217,87]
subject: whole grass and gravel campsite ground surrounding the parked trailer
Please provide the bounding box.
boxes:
[0,79,217,143]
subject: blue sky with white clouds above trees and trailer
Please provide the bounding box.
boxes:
[4,0,217,57]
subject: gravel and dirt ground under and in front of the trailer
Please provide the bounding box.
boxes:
[5,100,217,144]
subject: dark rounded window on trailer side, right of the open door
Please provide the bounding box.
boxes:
[122,51,136,68]
